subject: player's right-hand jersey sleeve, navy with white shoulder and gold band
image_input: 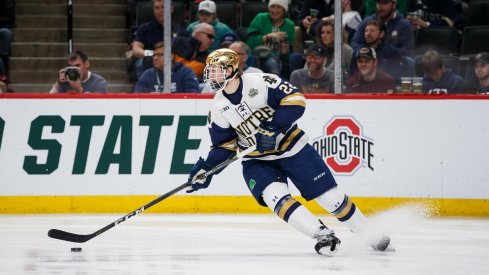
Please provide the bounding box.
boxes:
[263,74,306,132]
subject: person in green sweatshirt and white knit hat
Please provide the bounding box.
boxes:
[247,0,294,78]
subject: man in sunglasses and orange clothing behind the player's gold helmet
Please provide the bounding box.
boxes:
[172,23,215,82]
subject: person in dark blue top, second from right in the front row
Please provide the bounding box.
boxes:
[421,50,465,94]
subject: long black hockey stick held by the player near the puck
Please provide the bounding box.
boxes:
[48,146,256,243]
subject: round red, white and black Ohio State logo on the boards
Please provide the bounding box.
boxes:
[312,116,374,175]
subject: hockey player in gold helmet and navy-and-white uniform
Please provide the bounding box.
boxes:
[187,49,390,256]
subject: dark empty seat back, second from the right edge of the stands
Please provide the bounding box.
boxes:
[414,27,459,55]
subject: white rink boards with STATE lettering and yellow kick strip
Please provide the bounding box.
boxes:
[0,94,489,216]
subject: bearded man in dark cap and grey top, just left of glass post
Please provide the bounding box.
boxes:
[290,43,334,94]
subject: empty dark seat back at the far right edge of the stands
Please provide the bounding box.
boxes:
[461,25,489,55]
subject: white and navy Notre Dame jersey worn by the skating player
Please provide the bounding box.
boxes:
[208,73,308,160]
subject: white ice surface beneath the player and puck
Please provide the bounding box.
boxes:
[0,207,489,275]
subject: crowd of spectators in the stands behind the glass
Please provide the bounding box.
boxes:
[0,0,489,94]
